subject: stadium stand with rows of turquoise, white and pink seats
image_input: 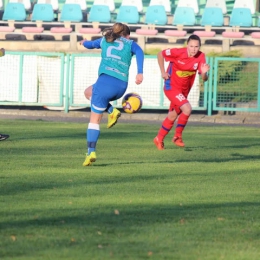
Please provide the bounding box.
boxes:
[0,0,260,54]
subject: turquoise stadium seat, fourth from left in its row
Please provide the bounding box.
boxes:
[88,5,111,23]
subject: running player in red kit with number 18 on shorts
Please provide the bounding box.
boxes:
[153,34,210,150]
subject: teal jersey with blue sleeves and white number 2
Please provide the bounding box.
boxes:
[84,37,144,82]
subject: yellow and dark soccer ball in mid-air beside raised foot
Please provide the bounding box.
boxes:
[122,93,143,114]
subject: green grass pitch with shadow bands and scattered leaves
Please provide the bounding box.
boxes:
[0,120,260,260]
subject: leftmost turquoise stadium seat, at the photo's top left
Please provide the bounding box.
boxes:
[3,2,26,21]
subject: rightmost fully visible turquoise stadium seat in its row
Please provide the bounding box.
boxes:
[229,8,253,27]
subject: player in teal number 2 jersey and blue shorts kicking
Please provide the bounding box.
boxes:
[81,23,144,166]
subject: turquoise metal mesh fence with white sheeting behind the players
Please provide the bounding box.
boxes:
[0,52,260,115]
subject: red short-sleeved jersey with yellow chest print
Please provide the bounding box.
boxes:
[162,48,206,97]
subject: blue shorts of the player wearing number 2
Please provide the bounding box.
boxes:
[91,74,128,114]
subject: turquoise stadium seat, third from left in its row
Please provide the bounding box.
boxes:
[59,4,83,22]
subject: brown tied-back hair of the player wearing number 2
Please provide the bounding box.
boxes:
[102,23,130,42]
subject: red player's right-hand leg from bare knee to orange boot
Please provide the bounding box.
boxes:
[172,100,192,147]
